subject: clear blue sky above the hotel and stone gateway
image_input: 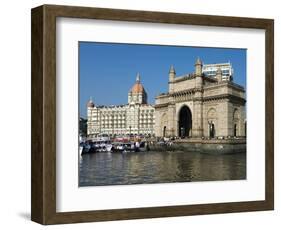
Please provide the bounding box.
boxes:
[79,42,246,117]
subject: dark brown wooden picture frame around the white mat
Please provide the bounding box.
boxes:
[31,5,274,224]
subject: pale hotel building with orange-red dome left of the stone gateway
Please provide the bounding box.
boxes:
[87,74,155,137]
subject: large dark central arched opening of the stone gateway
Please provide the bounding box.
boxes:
[179,105,192,138]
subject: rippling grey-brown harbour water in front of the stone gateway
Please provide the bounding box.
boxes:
[79,151,246,186]
